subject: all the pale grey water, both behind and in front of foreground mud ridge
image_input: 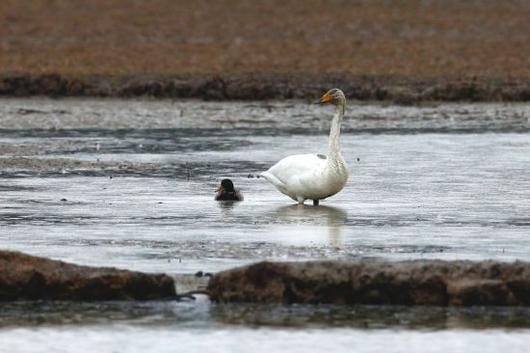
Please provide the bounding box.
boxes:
[0,100,530,352]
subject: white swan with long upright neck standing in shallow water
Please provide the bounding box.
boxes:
[261,88,348,206]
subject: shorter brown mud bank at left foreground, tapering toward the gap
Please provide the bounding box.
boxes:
[0,251,176,301]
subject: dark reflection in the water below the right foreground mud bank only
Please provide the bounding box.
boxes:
[210,304,530,329]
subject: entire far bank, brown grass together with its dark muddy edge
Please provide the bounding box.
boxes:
[0,0,530,101]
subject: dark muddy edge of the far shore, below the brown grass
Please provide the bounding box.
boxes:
[0,73,530,104]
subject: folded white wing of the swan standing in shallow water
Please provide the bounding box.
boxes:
[262,154,327,197]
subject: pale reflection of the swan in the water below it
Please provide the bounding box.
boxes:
[268,205,348,247]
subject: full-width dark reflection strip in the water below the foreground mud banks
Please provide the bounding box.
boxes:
[0,296,530,330]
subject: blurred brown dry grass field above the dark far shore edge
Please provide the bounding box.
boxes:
[0,0,530,80]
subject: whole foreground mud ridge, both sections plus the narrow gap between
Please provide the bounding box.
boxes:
[0,251,530,306]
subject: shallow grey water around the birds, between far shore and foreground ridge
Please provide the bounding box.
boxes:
[0,99,530,274]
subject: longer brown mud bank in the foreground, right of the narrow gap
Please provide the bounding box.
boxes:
[208,261,530,306]
